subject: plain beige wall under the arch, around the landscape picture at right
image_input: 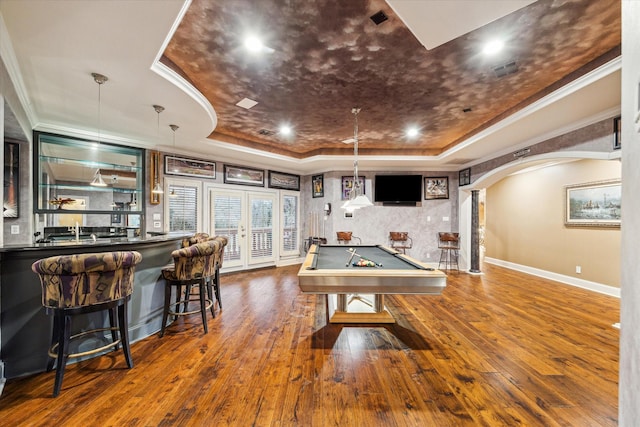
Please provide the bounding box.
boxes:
[485,160,621,287]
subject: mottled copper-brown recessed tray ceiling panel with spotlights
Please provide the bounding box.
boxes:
[162,0,621,158]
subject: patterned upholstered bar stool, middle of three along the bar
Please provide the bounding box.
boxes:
[160,240,220,337]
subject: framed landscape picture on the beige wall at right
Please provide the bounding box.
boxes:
[564,180,622,227]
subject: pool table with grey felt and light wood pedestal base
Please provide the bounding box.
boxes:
[298,245,447,323]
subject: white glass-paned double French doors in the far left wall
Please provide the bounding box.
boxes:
[209,188,277,268]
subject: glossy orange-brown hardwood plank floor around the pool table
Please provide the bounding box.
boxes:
[0,265,619,426]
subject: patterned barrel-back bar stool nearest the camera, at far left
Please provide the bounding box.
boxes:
[31,252,142,397]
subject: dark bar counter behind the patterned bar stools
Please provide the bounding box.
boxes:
[0,233,190,382]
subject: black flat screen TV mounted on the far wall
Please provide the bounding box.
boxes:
[374,175,422,206]
